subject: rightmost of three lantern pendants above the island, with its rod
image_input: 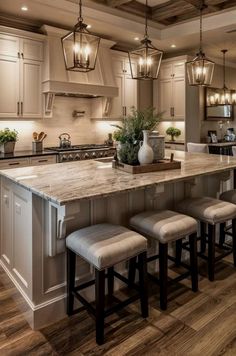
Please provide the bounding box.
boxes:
[186,0,215,86]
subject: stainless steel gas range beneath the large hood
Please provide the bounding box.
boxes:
[45,144,116,162]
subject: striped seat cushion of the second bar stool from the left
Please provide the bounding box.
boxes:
[130,210,197,244]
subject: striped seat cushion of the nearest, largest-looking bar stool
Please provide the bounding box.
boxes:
[66,224,147,270]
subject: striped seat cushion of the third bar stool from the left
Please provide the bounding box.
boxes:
[176,197,236,225]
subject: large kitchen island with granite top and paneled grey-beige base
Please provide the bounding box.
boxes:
[0,152,236,329]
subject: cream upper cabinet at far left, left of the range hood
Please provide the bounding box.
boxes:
[0,33,43,119]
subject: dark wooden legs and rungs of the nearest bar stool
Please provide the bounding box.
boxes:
[67,248,148,345]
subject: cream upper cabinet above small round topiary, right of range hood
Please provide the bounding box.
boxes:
[158,60,186,120]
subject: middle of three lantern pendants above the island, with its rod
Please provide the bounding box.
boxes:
[128,0,163,80]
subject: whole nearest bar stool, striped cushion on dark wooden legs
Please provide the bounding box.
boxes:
[66,224,148,345]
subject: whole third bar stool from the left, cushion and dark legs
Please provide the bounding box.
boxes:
[176,197,236,281]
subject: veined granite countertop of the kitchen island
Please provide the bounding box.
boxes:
[0,151,236,205]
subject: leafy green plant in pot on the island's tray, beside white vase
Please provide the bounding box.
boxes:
[112,107,162,165]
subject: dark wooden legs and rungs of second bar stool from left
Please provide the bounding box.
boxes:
[129,233,198,310]
